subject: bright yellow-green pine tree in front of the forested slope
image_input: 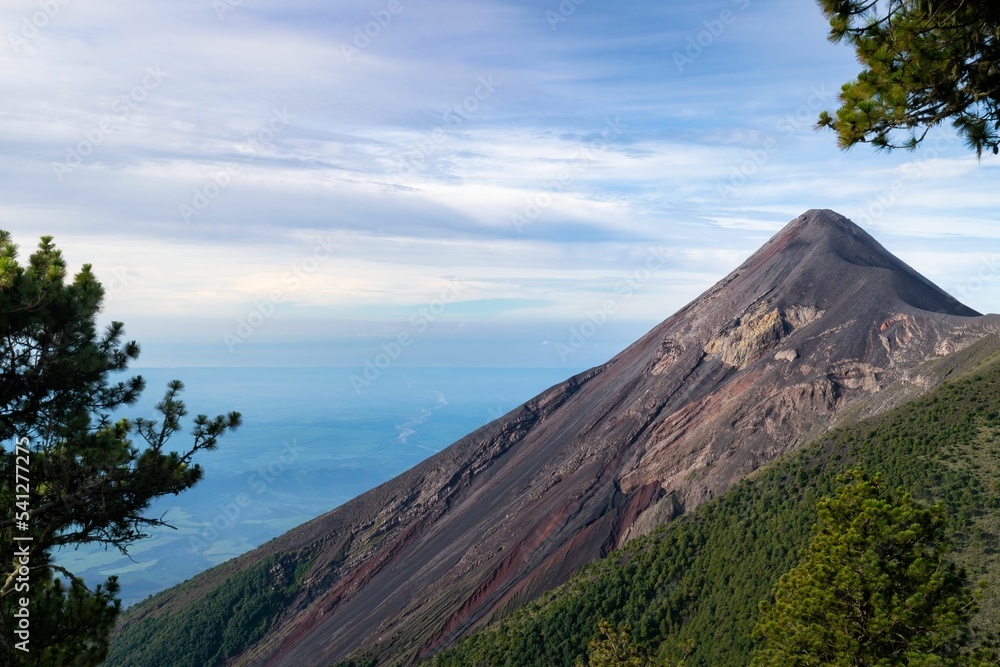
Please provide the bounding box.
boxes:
[750,470,992,667]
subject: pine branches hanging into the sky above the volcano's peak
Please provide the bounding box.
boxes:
[819,0,1000,156]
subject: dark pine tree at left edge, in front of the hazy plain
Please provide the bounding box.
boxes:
[0,230,240,665]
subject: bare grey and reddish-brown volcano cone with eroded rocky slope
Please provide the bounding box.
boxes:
[125,210,1000,666]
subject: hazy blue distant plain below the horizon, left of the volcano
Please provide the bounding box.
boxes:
[58,368,577,606]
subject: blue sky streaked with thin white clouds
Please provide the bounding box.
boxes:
[0,0,1000,370]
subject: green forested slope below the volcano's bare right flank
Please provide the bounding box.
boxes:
[429,340,1000,667]
